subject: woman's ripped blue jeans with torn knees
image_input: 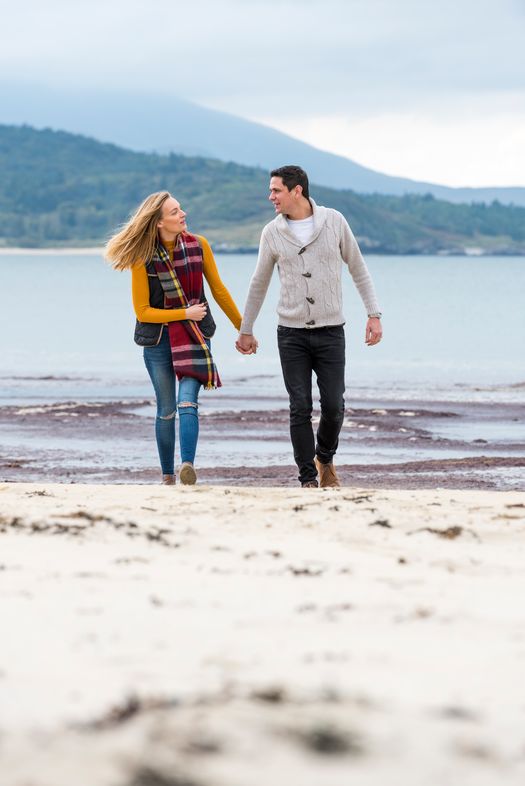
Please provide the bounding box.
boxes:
[144,328,205,475]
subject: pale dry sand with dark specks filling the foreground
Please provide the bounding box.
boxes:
[0,483,525,786]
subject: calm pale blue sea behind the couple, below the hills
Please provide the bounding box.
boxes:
[0,252,525,403]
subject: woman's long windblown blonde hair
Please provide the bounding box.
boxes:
[104,191,171,270]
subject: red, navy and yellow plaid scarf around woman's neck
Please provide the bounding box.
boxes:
[151,232,222,390]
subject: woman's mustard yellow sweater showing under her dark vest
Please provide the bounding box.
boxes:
[131,235,242,330]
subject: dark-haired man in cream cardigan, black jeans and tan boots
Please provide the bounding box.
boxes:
[236,166,382,488]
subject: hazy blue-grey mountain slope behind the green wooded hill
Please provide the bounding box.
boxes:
[0,83,525,205]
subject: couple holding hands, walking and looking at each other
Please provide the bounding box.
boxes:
[106,166,382,488]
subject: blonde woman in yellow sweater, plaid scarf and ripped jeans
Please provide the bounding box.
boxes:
[105,191,241,485]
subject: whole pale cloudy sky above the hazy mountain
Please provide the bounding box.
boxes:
[0,0,525,186]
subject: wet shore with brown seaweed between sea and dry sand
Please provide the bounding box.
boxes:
[0,399,525,490]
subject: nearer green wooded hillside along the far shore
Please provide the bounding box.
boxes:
[0,126,525,254]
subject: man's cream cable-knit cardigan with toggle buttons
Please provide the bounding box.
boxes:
[241,199,380,334]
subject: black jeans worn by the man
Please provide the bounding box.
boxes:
[277,325,345,483]
